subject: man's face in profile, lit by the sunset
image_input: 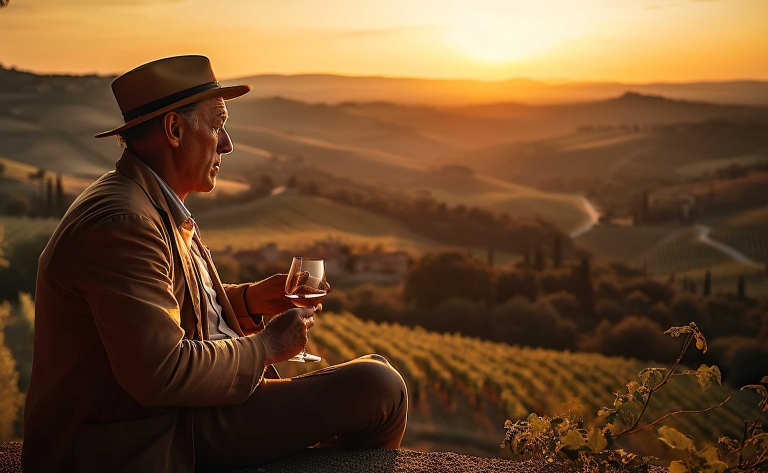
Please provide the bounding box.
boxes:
[182,98,232,192]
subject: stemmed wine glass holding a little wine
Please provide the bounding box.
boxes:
[285,256,329,363]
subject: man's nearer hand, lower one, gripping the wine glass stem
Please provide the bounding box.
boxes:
[258,307,315,365]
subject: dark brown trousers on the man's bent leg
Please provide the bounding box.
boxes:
[194,355,408,471]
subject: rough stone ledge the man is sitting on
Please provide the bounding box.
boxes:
[0,442,667,473]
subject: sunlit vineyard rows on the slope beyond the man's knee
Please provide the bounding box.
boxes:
[282,313,757,455]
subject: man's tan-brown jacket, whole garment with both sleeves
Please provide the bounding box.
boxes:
[22,151,266,473]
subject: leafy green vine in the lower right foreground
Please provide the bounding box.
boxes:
[501,322,768,473]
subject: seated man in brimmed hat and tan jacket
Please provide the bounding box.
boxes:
[22,56,407,473]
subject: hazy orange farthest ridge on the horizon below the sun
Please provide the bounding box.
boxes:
[225,74,768,107]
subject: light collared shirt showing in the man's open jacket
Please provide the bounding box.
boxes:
[150,168,239,340]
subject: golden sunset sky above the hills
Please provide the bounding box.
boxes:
[0,0,768,82]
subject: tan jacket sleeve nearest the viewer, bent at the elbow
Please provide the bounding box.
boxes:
[72,215,265,407]
